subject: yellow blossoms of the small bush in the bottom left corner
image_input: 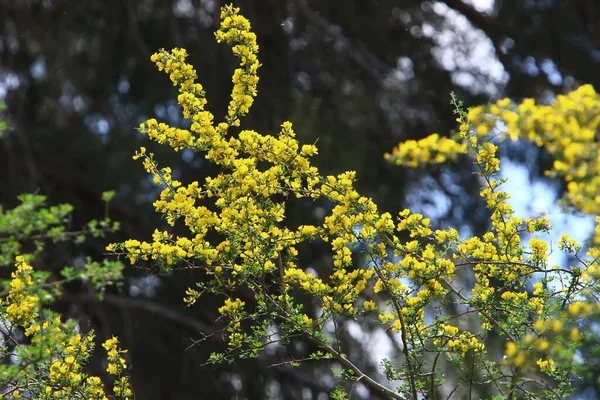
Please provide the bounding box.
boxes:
[1,256,133,400]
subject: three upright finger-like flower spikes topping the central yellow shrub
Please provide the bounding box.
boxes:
[139,5,260,167]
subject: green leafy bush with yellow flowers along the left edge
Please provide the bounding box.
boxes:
[0,194,132,400]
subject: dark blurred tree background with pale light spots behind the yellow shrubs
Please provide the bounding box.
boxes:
[0,0,600,400]
